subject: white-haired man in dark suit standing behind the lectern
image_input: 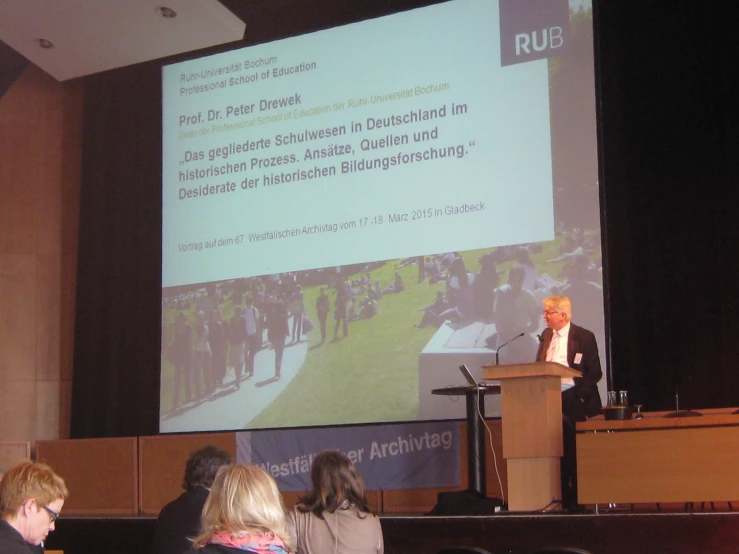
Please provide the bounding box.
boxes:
[536,296,603,511]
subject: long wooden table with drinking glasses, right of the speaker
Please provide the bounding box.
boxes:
[577,408,739,504]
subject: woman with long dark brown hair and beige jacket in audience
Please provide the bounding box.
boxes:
[287,450,384,554]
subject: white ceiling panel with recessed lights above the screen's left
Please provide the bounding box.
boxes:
[0,0,247,81]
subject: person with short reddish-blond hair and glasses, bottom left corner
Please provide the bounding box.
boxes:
[0,460,68,554]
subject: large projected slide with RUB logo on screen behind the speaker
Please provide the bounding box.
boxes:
[160,0,604,432]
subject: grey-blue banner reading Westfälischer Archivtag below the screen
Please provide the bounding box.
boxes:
[236,421,461,491]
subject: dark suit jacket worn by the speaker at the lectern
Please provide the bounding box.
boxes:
[536,323,603,419]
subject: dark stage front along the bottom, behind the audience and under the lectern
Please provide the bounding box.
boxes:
[46,506,739,554]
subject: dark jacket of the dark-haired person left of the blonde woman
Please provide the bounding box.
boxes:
[151,487,208,554]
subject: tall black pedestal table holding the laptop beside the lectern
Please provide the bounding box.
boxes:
[431,385,500,496]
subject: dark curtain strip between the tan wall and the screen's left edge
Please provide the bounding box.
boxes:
[71,64,162,438]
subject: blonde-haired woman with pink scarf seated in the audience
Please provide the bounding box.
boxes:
[191,464,293,554]
